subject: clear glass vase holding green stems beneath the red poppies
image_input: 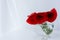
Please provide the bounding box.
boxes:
[40,22,54,40]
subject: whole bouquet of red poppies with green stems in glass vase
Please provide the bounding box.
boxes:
[26,8,57,40]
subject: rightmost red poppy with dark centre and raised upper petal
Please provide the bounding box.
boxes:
[47,8,57,22]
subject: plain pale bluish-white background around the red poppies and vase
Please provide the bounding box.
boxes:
[0,0,60,40]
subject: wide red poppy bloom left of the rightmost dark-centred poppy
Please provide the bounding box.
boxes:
[27,12,46,24]
